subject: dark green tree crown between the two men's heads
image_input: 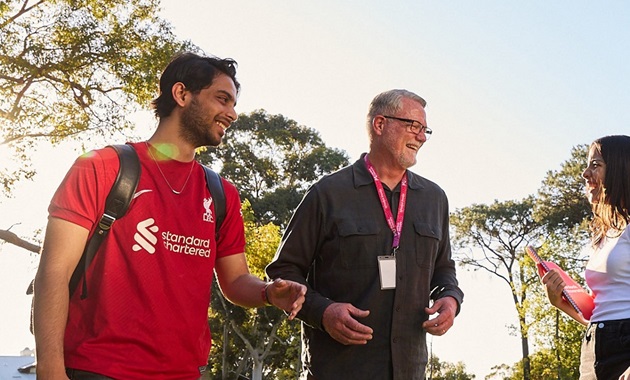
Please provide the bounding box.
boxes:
[200,110,348,227]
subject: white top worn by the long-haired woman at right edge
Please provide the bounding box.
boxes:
[585,226,630,322]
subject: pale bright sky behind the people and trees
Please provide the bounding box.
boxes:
[0,0,630,379]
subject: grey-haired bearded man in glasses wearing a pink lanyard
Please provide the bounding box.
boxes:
[267,90,463,380]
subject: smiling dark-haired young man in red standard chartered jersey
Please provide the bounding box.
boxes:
[34,53,305,380]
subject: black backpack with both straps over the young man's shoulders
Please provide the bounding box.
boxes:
[59,144,225,299]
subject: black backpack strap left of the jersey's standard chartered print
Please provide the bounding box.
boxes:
[69,144,140,299]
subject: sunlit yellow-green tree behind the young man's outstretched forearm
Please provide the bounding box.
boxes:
[209,200,300,379]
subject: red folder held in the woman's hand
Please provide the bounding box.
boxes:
[525,246,595,321]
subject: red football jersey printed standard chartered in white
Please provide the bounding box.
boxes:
[49,143,245,379]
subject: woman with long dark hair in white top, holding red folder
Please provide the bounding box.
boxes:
[542,135,630,380]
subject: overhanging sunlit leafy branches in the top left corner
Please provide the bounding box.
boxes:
[0,0,196,194]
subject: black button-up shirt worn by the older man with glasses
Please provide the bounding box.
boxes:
[267,157,463,380]
